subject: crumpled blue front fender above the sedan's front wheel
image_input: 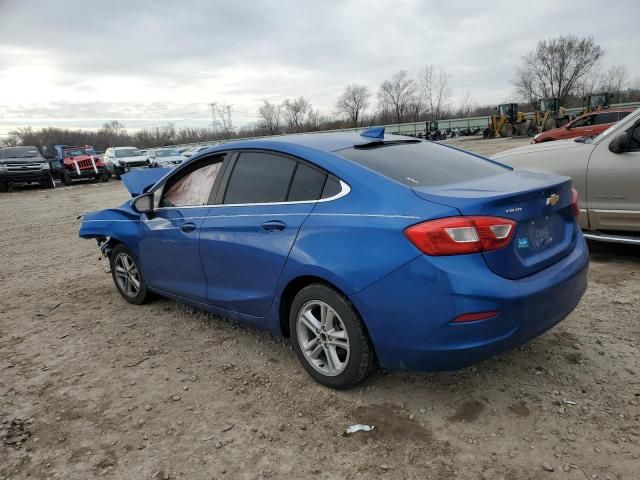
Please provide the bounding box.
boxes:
[79,202,140,256]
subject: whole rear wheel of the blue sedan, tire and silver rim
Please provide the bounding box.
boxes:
[289,284,376,390]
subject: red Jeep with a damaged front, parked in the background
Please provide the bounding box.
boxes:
[52,145,111,186]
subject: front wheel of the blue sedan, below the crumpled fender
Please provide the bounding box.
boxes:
[109,244,151,305]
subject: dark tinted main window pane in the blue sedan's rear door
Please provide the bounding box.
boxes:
[223,152,297,204]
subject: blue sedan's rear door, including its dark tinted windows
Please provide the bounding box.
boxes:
[200,151,327,317]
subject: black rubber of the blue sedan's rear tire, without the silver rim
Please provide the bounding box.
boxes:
[289,284,376,390]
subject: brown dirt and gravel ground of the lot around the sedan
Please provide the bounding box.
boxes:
[0,140,640,480]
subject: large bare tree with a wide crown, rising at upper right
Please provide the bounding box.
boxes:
[513,35,604,103]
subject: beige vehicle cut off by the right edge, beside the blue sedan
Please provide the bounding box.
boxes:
[494,109,640,244]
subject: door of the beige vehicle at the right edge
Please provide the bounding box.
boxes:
[587,117,640,232]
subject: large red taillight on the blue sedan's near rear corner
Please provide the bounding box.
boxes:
[404,217,516,255]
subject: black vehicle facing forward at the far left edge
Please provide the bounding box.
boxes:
[0,147,55,192]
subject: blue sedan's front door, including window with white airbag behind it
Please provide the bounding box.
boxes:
[139,155,224,303]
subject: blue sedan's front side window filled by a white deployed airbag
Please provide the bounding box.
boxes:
[160,156,224,208]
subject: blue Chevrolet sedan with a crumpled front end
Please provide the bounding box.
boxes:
[80,128,588,388]
